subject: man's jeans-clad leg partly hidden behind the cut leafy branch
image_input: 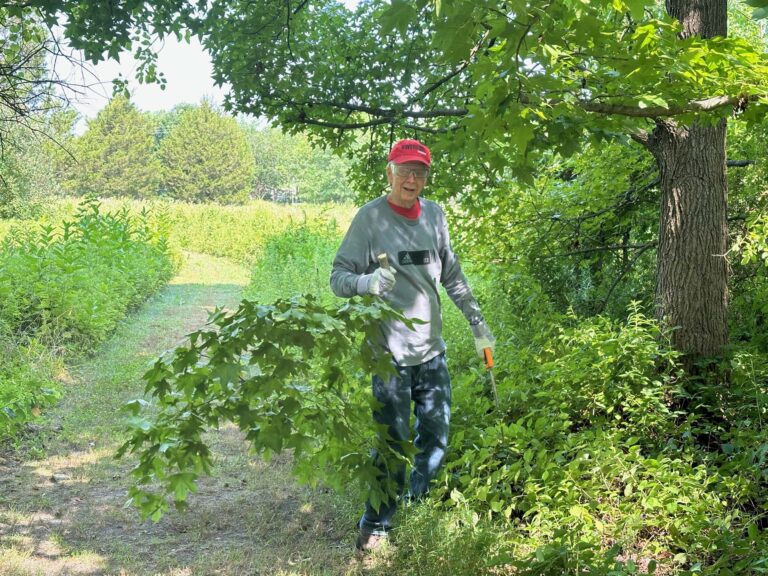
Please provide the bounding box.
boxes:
[358,366,412,534]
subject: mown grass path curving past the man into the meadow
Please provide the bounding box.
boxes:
[0,254,370,576]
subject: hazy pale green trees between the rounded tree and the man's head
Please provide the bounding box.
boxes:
[243,124,353,203]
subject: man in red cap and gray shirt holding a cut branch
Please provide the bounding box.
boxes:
[331,140,495,551]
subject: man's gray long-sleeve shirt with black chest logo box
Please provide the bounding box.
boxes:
[331,196,482,366]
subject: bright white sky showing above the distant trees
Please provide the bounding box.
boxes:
[57,38,225,126]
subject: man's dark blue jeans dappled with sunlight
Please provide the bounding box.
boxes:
[358,352,451,534]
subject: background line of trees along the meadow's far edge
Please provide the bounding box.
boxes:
[0,95,352,217]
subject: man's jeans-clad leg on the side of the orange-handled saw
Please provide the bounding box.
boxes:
[411,353,451,498]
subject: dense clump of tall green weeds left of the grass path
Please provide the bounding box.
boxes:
[0,200,172,350]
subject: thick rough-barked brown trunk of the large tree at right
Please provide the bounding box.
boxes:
[646,0,728,360]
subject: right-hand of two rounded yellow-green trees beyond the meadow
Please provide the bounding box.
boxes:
[158,102,253,204]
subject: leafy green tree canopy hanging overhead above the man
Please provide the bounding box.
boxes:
[21,0,768,191]
